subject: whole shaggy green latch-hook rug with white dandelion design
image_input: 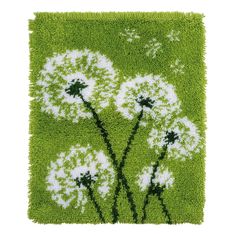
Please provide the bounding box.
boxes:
[28,13,206,224]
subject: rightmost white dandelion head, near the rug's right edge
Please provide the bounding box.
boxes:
[147,117,201,160]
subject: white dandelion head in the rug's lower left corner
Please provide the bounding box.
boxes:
[46,144,114,212]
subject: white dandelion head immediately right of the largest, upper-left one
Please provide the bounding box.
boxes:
[115,75,180,125]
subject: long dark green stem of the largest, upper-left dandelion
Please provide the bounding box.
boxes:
[78,93,138,223]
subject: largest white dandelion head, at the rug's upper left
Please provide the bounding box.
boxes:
[36,49,116,122]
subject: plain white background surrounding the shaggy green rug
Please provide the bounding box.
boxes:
[0,0,236,236]
